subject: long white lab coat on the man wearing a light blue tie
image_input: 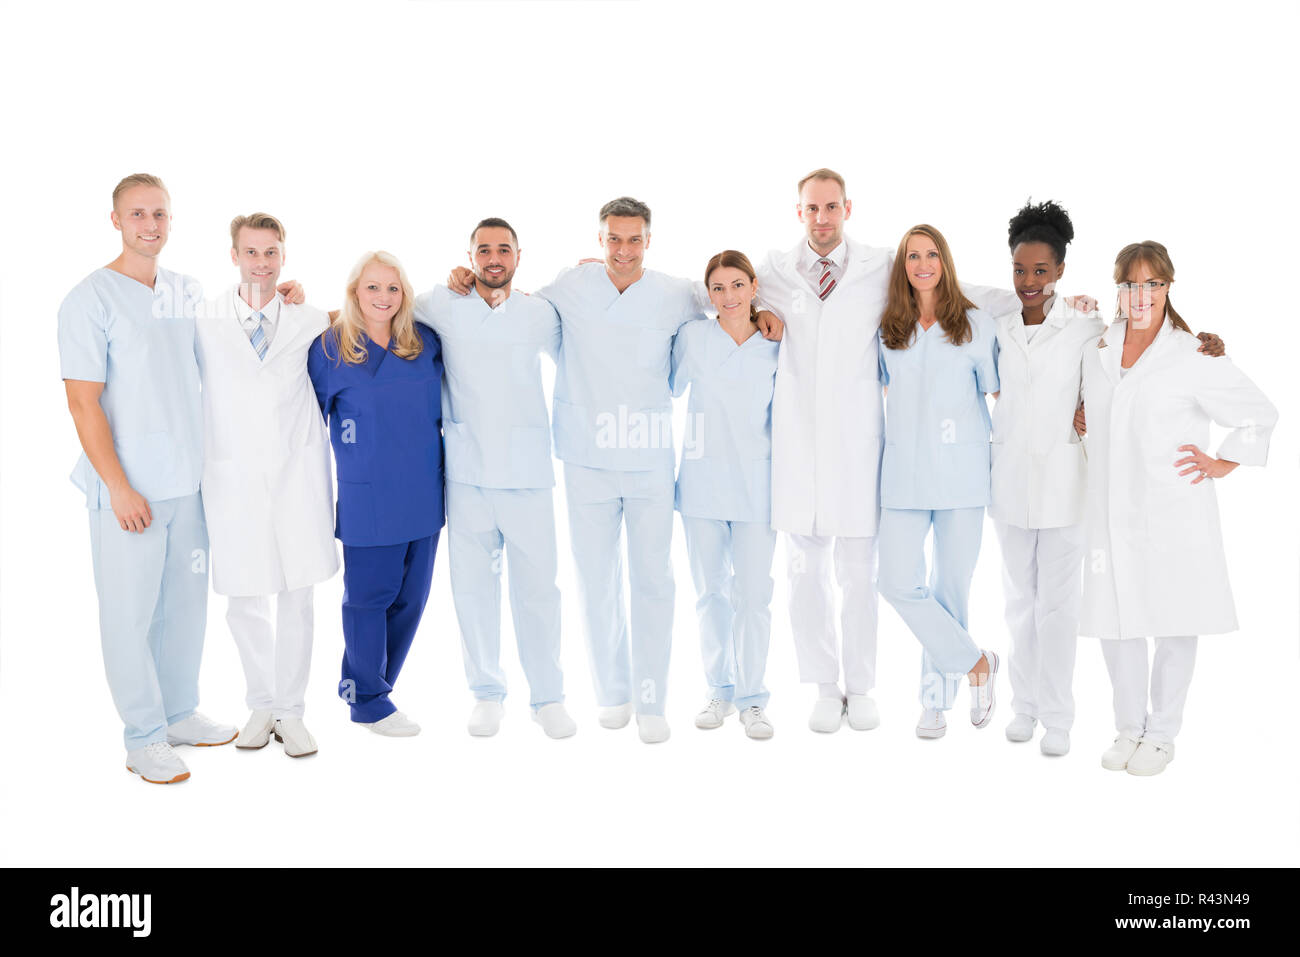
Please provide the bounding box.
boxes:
[196,287,338,596]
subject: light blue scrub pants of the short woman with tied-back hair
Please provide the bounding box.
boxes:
[681,515,776,711]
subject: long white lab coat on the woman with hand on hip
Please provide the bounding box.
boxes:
[1079,319,1278,638]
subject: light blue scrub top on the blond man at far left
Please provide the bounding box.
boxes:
[59,267,203,508]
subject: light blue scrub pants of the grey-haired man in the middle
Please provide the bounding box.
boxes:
[564,462,673,715]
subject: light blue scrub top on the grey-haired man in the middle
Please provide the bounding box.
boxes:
[540,263,706,472]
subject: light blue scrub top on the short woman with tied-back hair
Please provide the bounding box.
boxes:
[672,320,780,525]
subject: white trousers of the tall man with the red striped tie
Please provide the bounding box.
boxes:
[785,534,878,694]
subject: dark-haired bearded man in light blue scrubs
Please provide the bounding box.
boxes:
[415,218,577,737]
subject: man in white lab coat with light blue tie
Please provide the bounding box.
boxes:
[198,213,338,758]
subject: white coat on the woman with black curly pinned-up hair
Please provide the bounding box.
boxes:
[988,295,1106,528]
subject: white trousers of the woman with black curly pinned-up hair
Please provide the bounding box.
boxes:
[993,521,1084,731]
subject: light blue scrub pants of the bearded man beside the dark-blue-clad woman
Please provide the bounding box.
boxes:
[447,481,564,709]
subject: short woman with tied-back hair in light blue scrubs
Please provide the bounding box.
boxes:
[672,250,780,740]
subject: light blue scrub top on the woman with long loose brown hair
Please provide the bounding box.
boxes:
[880,309,998,508]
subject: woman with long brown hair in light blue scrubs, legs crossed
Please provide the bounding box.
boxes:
[879,225,998,737]
